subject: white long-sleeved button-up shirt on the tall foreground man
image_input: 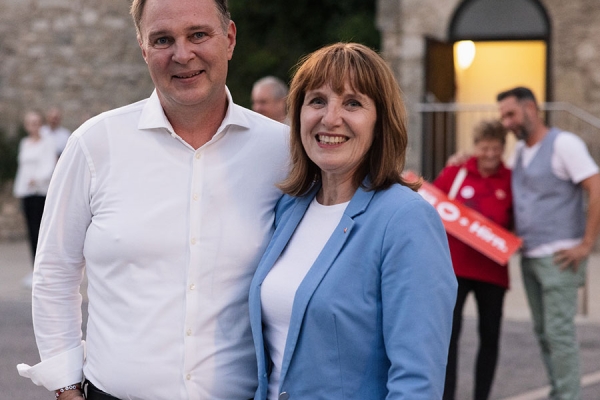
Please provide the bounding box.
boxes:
[19,92,289,400]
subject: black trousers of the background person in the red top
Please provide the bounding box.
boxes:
[443,278,506,400]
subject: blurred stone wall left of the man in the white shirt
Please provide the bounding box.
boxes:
[0,0,153,240]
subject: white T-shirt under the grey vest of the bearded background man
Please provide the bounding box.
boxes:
[509,131,598,257]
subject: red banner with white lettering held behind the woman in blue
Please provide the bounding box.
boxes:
[404,172,522,265]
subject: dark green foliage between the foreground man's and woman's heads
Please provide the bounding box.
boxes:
[227,0,380,107]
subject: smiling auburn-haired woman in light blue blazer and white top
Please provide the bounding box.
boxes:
[249,43,456,400]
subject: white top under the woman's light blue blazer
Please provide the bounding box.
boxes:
[260,197,350,400]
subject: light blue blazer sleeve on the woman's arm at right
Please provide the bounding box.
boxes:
[381,198,457,400]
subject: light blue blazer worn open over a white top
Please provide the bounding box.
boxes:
[249,185,457,400]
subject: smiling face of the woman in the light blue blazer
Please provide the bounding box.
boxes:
[300,83,377,186]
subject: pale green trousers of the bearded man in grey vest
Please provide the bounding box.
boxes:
[521,257,587,400]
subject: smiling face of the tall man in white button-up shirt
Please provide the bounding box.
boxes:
[138,0,236,111]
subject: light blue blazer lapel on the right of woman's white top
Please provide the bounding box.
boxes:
[280,188,375,384]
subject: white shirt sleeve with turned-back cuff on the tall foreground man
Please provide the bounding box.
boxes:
[18,137,94,390]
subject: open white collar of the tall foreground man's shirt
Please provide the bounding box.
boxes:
[138,87,250,136]
